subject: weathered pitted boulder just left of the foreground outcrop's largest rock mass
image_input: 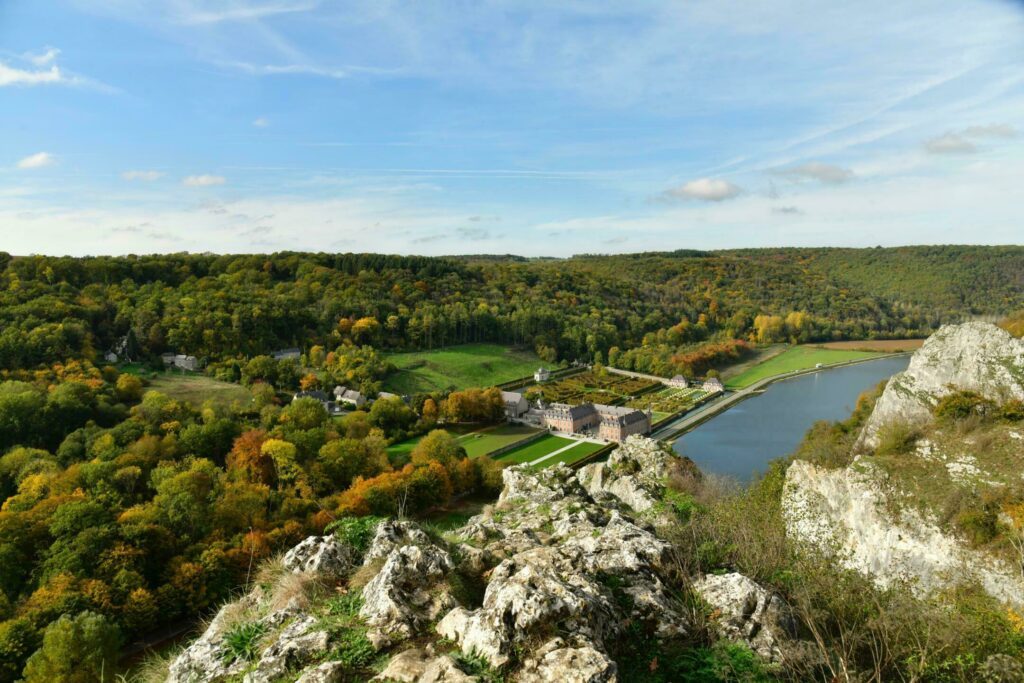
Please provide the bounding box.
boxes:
[359,540,456,648]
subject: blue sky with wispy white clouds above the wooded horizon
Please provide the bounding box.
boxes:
[0,0,1024,256]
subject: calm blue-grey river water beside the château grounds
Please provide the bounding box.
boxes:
[673,356,910,483]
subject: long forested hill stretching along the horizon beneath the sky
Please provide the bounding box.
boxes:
[0,246,1024,369]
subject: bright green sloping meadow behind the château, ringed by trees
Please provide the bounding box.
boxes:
[384,344,544,394]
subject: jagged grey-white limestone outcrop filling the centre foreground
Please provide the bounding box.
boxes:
[169,438,776,683]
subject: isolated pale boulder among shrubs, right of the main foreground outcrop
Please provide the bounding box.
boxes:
[693,572,796,661]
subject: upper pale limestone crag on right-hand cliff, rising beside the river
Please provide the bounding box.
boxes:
[856,323,1024,451]
